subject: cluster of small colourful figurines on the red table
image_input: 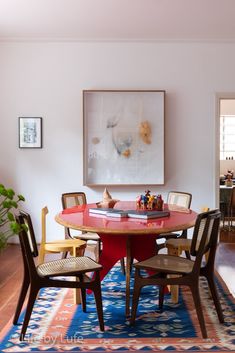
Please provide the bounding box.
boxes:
[136,190,164,211]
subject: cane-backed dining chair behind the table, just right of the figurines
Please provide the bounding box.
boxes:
[156,191,192,253]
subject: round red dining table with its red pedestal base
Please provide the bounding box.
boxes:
[55,201,197,315]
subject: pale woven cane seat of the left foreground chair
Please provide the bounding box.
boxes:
[37,256,102,277]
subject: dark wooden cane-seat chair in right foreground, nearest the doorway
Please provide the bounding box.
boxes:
[131,210,224,338]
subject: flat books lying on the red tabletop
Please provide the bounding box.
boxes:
[89,208,170,219]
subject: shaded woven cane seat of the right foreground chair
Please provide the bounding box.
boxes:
[135,254,194,274]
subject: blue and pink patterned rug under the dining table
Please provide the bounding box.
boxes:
[0,266,235,353]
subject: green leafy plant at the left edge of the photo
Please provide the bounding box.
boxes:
[0,184,25,252]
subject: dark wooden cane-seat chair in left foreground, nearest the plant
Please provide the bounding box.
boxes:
[13,211,104,341]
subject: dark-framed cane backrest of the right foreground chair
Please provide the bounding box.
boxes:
[190,209,221,270]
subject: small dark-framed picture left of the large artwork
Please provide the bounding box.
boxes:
[19,118,42,148]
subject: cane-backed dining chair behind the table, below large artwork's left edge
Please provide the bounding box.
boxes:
[61,192,101,261]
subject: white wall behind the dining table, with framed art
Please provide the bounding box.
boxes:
[0,42,235,239]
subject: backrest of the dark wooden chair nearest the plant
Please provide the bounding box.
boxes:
[16,211,38,277]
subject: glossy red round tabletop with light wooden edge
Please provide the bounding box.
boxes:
[56,201,197,237]
